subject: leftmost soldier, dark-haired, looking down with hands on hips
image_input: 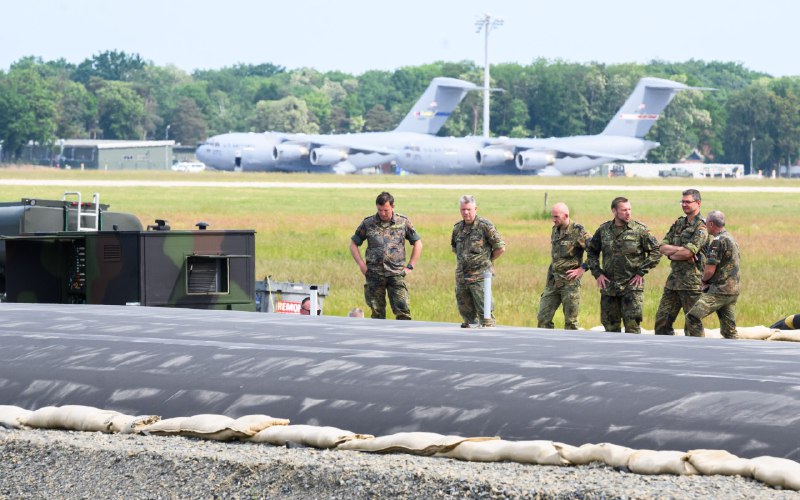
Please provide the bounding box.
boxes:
[350,191,422,319]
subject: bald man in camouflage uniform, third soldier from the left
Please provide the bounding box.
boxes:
[537,203,591,330]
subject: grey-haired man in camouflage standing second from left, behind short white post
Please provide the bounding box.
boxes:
[450,195,506,328]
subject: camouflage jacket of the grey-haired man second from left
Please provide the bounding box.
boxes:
[450,217,506,277]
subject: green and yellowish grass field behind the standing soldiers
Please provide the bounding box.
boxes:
[0,168,800,329]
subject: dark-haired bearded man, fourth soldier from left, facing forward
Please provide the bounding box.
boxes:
[586,196,661,333]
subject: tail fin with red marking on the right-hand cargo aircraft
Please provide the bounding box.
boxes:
[602,78,709,139]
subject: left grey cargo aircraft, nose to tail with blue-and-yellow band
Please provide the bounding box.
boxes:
[195,77,480,174]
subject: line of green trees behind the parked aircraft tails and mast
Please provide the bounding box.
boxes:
[0,51,800,171]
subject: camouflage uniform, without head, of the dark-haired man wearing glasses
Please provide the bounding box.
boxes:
[655,213,708,335]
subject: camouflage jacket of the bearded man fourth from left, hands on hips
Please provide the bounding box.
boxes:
[586,220,661,295]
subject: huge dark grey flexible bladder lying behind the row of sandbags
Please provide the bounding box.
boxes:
[0,304,800,460]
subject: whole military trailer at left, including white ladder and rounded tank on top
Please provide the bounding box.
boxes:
[0,193,255,311]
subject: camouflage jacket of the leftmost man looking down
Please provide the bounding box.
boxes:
[350,213,421,276]
